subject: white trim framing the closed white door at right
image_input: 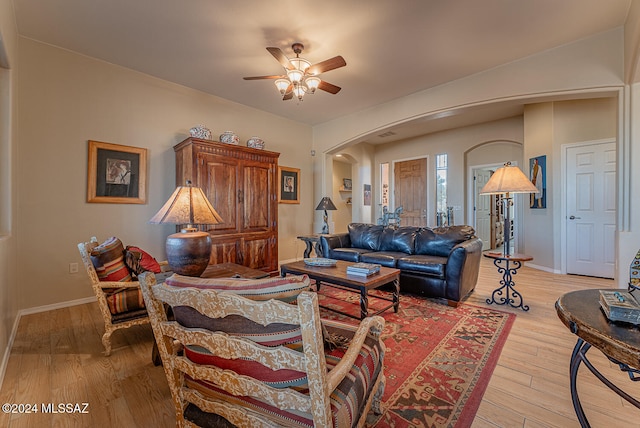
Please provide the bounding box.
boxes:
[560,137,620,280]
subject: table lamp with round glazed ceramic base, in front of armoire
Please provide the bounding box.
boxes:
[149,180,222,276]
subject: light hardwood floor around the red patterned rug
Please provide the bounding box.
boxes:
[0,259,640,428]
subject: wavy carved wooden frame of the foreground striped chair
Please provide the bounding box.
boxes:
[140,273,385,427]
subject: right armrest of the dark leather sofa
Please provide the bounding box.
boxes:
[445,238,482,302]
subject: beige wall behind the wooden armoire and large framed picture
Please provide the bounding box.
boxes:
[17,39,314,308]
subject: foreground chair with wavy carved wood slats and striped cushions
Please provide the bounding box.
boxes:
[140,273,385,427]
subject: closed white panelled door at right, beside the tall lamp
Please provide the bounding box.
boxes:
[566,142,616,278]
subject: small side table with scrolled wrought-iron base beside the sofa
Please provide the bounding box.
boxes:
[482,252,533,311]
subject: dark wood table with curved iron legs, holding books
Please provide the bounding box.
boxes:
[556,289,640,427]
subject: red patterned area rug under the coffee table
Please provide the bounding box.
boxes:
[319,286,515,428]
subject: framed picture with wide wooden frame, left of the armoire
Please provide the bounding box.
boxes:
[87,141,147,204]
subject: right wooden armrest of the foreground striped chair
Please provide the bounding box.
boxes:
[322,316,385,391]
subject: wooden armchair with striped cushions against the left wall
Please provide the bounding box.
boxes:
[78,238,169,356]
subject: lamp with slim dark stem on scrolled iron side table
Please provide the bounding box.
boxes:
[480,162,538,256]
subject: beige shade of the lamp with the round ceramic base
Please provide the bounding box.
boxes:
[149,182,222,225]
